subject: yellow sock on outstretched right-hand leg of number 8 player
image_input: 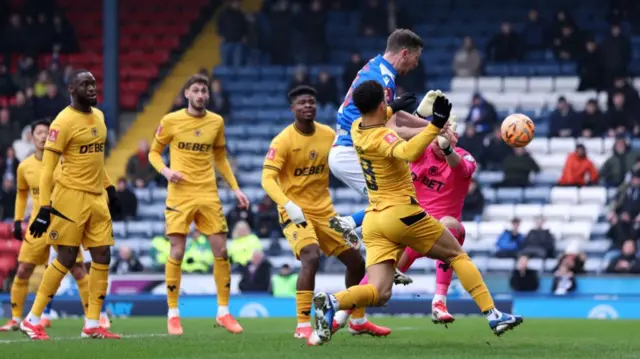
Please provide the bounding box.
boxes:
[450,254,495,313]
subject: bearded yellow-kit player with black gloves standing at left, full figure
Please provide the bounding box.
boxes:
[20,70,120,340]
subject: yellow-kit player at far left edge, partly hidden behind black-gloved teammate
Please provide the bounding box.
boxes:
[0,120,89,332]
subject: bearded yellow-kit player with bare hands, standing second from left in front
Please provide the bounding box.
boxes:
[149,75,249,335]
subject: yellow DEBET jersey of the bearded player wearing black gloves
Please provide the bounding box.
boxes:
[44,106,107,194]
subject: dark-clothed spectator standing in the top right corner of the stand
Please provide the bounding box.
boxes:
[600,24,632,87]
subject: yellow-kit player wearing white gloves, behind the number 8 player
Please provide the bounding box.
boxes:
[262,86,390,339]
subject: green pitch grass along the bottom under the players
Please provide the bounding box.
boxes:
[0,318,640,359]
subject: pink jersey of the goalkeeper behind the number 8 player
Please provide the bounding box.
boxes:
[411,146,476,221]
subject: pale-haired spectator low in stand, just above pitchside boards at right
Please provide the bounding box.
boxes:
[551,241,587,295]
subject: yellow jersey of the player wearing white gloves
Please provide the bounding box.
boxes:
[263,123,336,219]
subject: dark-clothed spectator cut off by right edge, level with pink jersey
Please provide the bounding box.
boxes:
[607,170,640,249]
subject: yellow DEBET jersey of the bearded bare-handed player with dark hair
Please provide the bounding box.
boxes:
[153,109,226,197]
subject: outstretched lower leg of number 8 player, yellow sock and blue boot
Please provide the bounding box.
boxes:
[424,226,523,335]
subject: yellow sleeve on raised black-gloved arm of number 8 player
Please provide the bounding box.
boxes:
[377,124,440,162]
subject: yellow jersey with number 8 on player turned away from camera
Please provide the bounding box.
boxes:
[351,119,439,211]
